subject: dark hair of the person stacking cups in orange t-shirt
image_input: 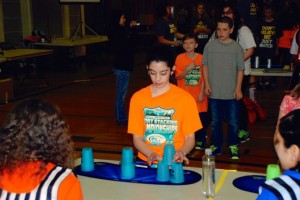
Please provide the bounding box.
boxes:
[147,46,174,69]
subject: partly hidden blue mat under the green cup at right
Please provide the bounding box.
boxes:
[232,175,266,193]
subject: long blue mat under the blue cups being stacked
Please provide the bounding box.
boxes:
[74,162,202,185]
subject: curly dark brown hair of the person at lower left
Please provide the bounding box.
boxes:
[0,99,73,174]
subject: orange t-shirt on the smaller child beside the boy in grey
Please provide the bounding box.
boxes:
[175,53,208,113]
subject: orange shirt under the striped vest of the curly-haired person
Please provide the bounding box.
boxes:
[0,162,83,200]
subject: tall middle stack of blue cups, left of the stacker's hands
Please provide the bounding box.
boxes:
[121,147,135,179]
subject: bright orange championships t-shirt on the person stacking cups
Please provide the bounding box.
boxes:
[128,85,202,160]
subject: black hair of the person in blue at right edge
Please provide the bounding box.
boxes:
[279,109,300,148]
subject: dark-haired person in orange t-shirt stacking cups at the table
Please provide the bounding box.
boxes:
[128,47,202,166]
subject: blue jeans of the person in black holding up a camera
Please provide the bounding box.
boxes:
[113,68,130,121]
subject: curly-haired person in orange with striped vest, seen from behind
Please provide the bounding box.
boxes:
[0,99,83,200]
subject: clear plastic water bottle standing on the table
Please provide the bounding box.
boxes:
[202,148,216,198]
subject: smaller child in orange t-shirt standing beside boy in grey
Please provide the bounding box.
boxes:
[175,34,208,150]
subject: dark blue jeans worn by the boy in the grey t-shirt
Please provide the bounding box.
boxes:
[208,98,240,149]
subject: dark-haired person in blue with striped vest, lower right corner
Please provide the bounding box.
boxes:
[257,109,300,200]
